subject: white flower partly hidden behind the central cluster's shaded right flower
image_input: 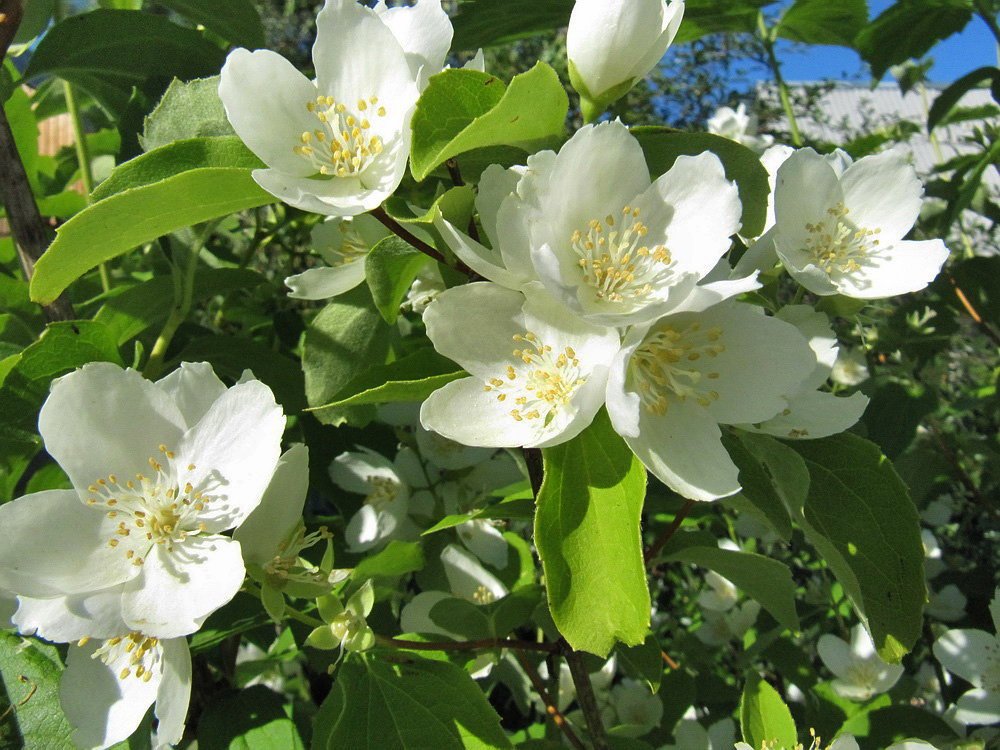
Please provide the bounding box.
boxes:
[740,305,868,439]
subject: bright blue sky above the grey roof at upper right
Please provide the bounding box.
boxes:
[779,0,997,83]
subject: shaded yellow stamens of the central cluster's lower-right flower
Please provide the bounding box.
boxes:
[629,323,726,417]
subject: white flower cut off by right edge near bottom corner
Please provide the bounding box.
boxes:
[934,589,1000,724]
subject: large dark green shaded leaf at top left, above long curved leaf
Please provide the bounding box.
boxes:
[24,9,226,119]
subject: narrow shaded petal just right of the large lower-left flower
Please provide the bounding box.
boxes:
[233,443,309,563]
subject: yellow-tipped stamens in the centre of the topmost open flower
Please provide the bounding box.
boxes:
[292,96,385,177]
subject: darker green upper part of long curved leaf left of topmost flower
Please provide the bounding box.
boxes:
[93,135,264,202]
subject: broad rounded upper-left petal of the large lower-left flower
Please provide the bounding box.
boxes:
[38,362,185,500]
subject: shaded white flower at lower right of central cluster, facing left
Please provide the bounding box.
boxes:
[607,303,816,500]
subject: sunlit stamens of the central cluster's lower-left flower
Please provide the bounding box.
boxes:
[483,331,586,426]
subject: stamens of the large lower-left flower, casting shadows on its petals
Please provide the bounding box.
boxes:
[86,445,212,565]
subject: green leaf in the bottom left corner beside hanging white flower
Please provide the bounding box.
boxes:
[0,631,77,750]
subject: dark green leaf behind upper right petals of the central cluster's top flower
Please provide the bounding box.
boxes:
[631,126,771,237]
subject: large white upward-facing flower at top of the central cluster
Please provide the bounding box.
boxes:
[436,121,759,326]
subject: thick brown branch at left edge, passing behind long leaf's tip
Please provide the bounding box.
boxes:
[0,101,75,322]
